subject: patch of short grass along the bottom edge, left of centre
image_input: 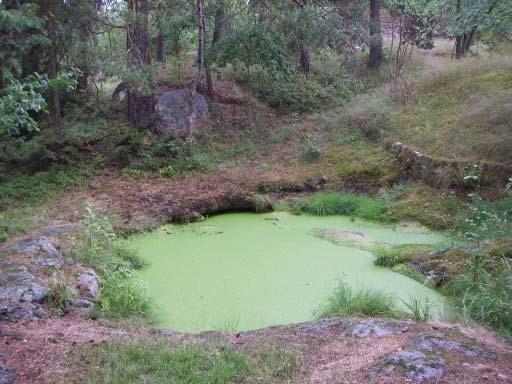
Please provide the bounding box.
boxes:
[77,340,299,384]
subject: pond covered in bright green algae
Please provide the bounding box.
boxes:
[131,213,443,332]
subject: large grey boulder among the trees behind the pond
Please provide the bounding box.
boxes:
[155,88,208,133]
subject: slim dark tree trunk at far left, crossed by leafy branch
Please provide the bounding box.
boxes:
[46,2,62,132]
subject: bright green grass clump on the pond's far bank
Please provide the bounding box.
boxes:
[304,192,386,221]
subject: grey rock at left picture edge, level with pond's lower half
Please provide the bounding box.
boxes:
[0,273,48,303]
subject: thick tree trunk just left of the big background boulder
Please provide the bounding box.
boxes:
[126,0,154,127]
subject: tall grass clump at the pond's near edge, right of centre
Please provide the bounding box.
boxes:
[316,281,397,319]
